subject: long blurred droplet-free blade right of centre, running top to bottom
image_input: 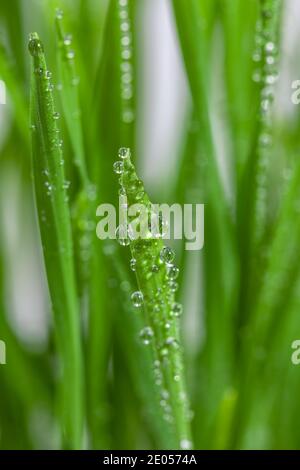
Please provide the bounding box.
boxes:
[173,0,237,446]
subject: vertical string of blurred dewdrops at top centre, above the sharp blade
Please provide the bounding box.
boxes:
[118,0,134,124]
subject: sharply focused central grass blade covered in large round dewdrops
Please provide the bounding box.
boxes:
[114,148,192,448]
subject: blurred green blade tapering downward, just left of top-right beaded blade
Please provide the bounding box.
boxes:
[221,0,258,186]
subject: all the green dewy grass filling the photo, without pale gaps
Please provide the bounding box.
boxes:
[0,0,300,449]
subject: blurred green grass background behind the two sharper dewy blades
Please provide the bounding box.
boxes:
[0,0,300,449]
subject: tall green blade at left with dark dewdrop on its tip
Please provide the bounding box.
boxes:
[29,33,83,448]
